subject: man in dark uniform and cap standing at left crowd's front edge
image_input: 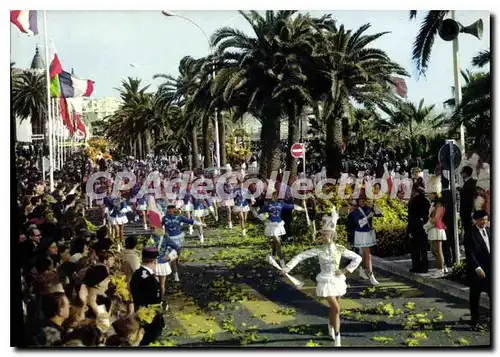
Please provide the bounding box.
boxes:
[130,247,165,346]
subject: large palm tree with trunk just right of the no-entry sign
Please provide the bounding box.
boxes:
[307,24,408,177]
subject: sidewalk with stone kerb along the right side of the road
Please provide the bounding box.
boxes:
[372,252,490,310]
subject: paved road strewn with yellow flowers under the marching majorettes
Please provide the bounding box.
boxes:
[127,223,490,348]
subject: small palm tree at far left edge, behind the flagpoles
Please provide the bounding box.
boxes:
[12,71,47,135]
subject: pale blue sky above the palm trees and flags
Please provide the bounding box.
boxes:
[11,10,490,108]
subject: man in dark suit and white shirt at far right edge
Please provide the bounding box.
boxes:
[464,211,491,325]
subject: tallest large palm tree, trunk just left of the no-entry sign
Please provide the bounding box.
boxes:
[211,11,312,177]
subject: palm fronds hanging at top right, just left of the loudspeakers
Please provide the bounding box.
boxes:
[410,10,450,74]
